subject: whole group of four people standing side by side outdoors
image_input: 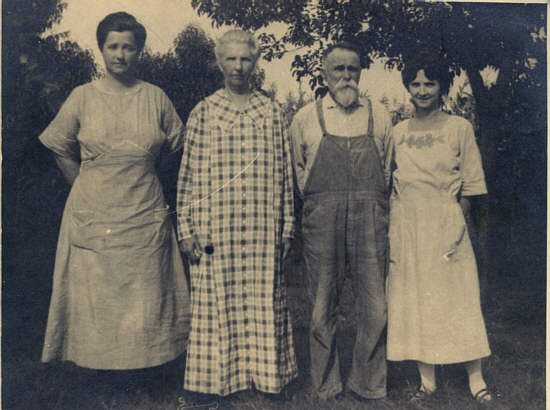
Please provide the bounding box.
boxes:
[40,12,491,403]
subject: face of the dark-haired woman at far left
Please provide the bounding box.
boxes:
[101,31,139,77]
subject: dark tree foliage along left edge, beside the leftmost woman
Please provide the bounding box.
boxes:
[2,0,96,359]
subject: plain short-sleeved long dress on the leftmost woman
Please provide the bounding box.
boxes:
[40,82,189,369]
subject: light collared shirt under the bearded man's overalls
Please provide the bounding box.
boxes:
[290,94,393,194]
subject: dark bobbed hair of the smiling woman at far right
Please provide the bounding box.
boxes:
[401,52,452,95]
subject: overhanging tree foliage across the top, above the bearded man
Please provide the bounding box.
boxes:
[192,0,546,105]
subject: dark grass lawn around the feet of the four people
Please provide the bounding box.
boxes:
[2,245,546,410]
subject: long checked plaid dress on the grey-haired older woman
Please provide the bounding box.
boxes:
[178,90,297,396]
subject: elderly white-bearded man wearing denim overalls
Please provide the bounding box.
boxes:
[290,43,393,399]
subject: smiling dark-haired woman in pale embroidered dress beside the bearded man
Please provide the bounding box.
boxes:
[387,54,492,404]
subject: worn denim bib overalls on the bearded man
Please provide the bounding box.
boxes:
[302,100,388,399]
